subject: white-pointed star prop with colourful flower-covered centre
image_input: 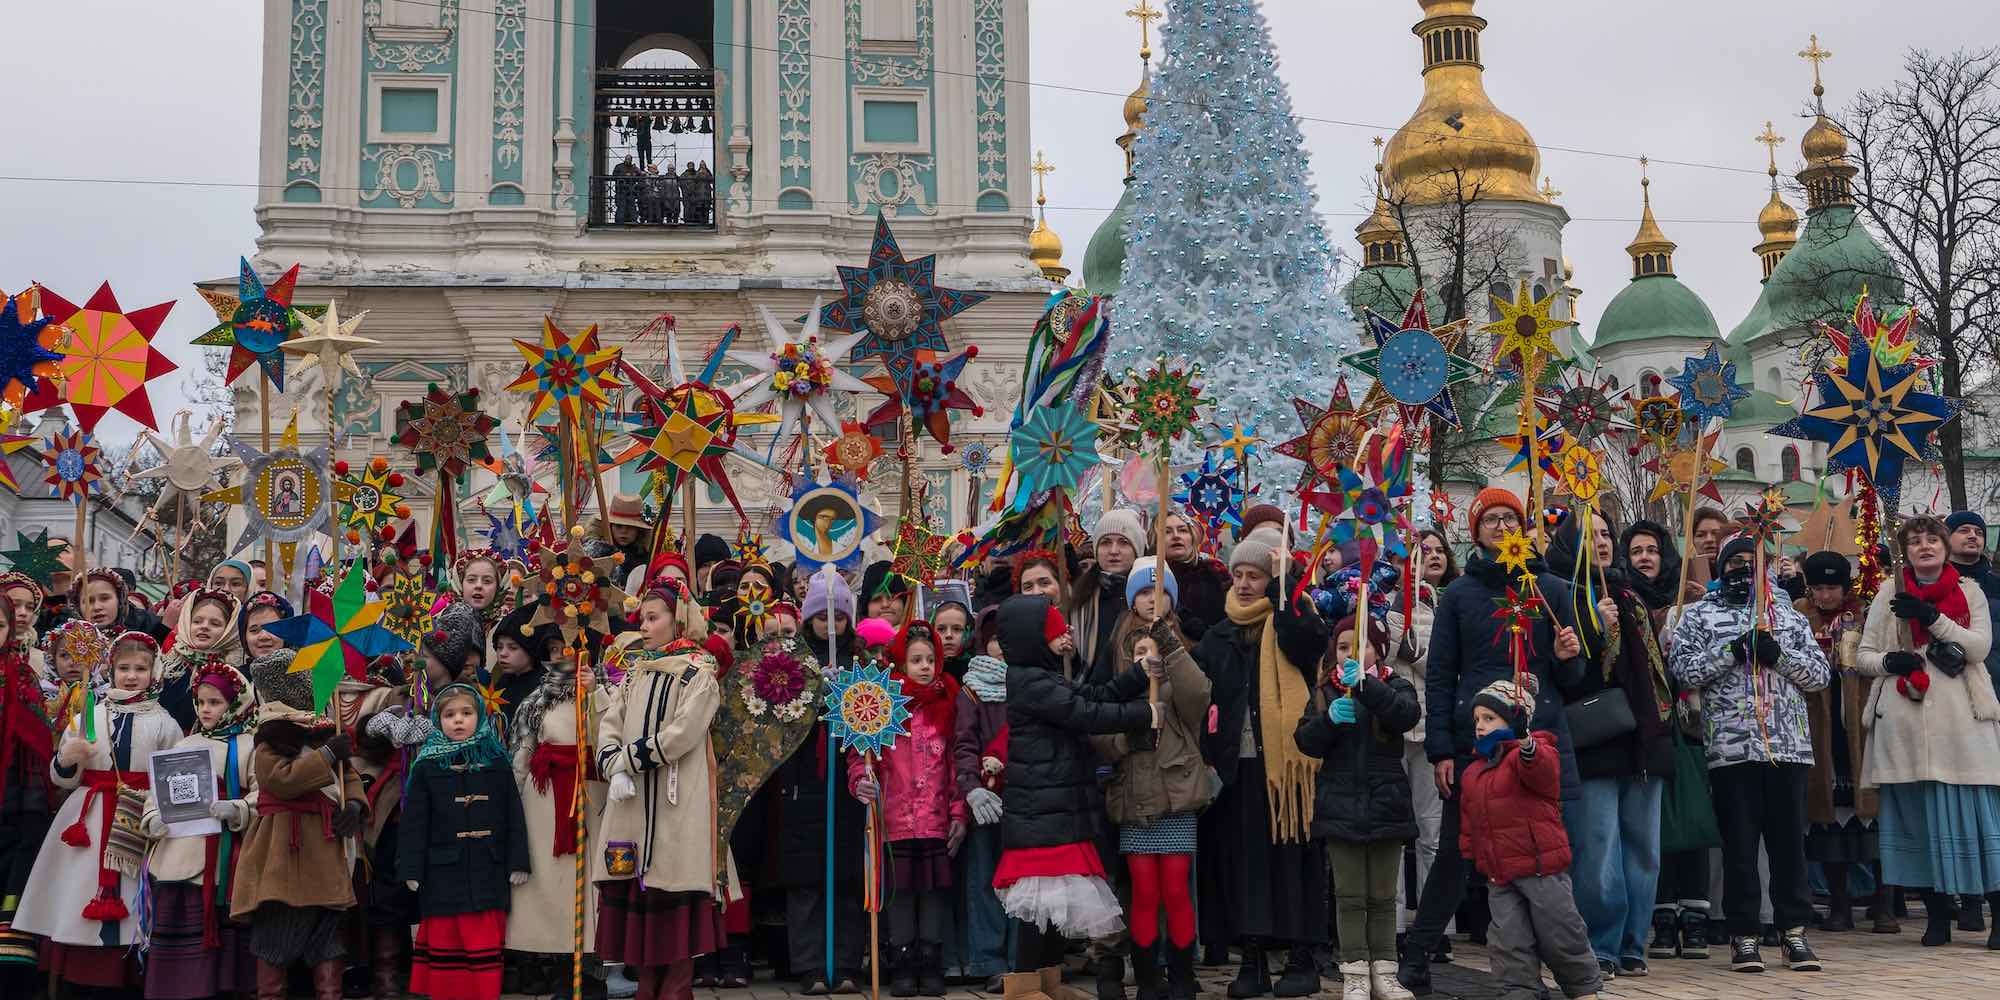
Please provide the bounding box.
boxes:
[728,300,868,452]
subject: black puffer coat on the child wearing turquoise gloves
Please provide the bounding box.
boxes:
[1294,674,1428,844]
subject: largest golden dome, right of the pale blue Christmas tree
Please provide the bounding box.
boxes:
[1384,0,1548,204]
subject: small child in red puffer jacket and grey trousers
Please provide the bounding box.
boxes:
[1458,674,1602,1000]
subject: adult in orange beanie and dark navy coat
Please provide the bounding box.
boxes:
[1398,486,1588,996]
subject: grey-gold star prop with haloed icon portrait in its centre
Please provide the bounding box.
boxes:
[202,414,350,580]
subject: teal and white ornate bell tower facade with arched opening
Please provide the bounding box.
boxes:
[254,0,1050,548]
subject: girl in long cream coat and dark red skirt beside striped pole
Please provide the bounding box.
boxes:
[592,586,734,1000]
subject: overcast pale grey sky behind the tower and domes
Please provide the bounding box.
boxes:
[0,0,1968,446]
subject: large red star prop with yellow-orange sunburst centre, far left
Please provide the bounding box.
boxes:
[22,282,178,432]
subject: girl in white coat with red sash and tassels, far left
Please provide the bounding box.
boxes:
[14,622,180,988]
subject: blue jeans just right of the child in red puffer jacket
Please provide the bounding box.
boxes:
[1562,776,1664,962]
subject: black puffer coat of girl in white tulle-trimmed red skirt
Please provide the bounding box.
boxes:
[1000,594,1152,848]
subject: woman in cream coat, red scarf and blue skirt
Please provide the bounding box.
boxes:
[1858,516,2000,950]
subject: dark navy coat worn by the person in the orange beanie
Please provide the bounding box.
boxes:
[1424,550,1586,798]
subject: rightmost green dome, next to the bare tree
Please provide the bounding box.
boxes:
[1730,204,1904,348]
